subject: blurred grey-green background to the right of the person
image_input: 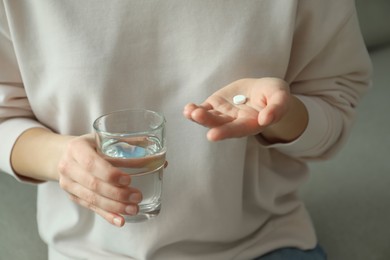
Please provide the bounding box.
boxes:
[302,0,390,260]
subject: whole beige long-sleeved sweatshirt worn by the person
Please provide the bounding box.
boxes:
[0,0,371,260]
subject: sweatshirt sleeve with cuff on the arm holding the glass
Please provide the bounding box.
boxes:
[0,2,44,183]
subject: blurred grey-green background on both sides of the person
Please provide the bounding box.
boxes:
[0,0,390,260]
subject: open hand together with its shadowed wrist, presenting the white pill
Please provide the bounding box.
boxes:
[183,78,308,142]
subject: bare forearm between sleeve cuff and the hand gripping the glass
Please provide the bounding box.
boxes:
[11,128,72,181]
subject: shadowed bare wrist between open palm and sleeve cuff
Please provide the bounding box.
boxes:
[261,95,309,143]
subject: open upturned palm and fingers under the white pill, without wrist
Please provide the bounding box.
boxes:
[183,78,290,141]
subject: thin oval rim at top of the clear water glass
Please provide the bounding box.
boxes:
[92,108,166,137]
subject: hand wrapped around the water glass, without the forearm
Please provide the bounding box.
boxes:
[58,134,142,226]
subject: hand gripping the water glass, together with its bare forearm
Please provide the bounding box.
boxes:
[11,128,142,226]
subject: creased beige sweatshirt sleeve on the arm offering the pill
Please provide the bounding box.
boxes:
[260,1,372,160]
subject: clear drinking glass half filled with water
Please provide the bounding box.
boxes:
[93,109,166,222]
